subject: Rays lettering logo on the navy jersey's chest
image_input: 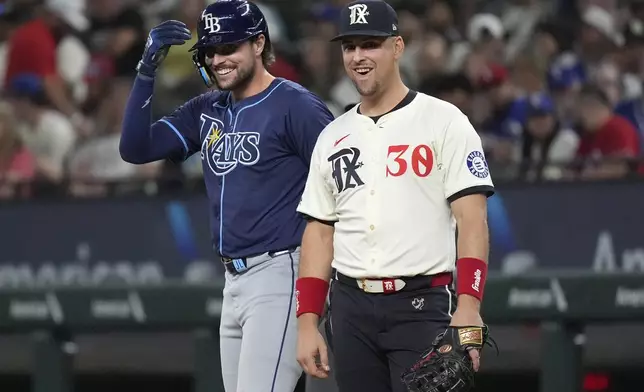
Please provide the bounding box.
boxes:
[200,114,260,176]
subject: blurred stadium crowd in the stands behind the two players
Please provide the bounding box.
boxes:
[0,0,644,198]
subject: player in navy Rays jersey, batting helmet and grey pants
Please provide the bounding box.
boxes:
[120,0,333,392]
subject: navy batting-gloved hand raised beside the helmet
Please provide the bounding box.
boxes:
[136,20,192,77]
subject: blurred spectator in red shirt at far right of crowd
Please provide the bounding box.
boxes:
[577,86,641,179]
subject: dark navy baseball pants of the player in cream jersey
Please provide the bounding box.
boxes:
[329,273,456,392]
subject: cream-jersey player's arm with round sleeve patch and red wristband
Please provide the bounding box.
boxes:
[439,113,494,316]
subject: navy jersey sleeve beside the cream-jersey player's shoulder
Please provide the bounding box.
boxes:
[285,93,333,167]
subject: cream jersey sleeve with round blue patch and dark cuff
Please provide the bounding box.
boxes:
[440,114,494,198]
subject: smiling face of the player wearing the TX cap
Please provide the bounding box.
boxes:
[342,37,404,97]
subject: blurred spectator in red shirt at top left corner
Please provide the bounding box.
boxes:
[4,0,89,127]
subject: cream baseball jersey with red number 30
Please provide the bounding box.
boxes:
[297,91,494,278]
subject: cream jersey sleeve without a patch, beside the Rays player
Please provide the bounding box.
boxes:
[297,139,338,221]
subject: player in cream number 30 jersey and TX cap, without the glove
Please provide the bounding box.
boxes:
[296,0,494,392]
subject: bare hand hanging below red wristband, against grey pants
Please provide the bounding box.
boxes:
[297,323,331,378]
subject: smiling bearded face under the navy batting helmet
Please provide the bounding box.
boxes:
[205,35,264,90]
